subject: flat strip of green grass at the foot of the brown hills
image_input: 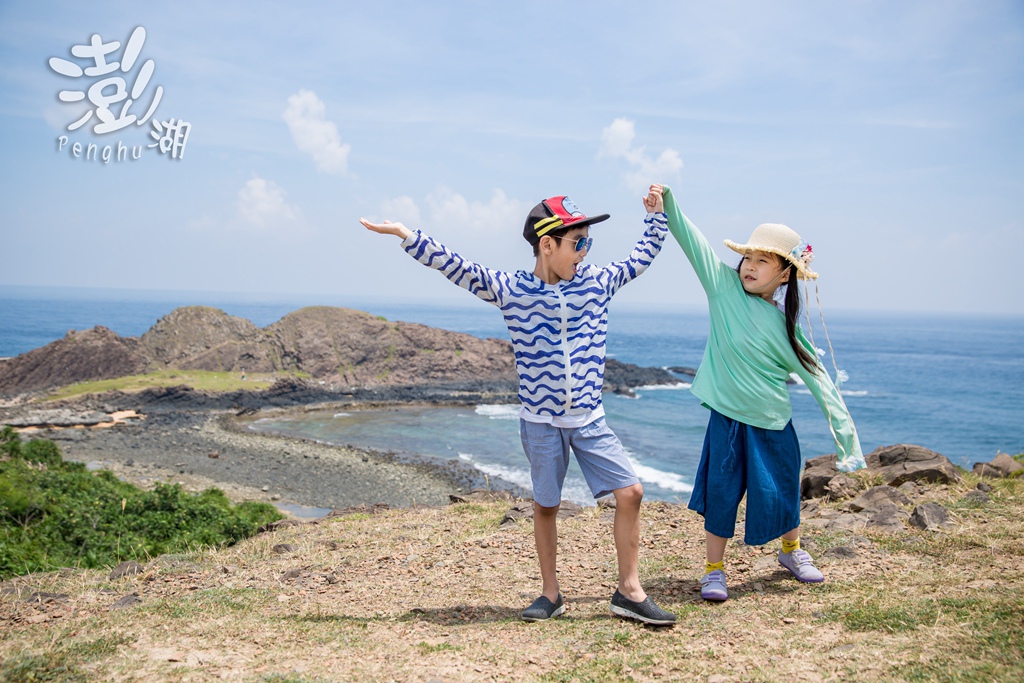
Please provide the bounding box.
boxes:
[47,370,309,400]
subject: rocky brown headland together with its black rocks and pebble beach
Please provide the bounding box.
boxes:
[0,306,685,508]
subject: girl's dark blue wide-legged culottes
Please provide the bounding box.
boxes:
[688,410,801,546]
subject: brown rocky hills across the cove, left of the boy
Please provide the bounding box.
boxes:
[0,306,515,395]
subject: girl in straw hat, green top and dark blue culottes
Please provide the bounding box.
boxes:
[664,187,864,601]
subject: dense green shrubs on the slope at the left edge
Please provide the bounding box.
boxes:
[0,433,282,579]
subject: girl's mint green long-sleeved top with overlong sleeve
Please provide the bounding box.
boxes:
[665,187,864,472]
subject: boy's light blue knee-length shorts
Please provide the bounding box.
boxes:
[519,418,640,508]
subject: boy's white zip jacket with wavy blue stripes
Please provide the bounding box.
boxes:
[402,213,668,422]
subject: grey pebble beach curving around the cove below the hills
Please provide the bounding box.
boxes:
[29,402,526,517]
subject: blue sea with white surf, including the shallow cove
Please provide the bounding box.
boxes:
[0,287,1024,503]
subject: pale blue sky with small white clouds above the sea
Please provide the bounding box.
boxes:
[0,0,1024,315]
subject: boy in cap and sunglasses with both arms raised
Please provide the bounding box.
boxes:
[359,185,676,625]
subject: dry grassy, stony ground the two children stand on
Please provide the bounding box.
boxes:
[0,480,1024,683]
